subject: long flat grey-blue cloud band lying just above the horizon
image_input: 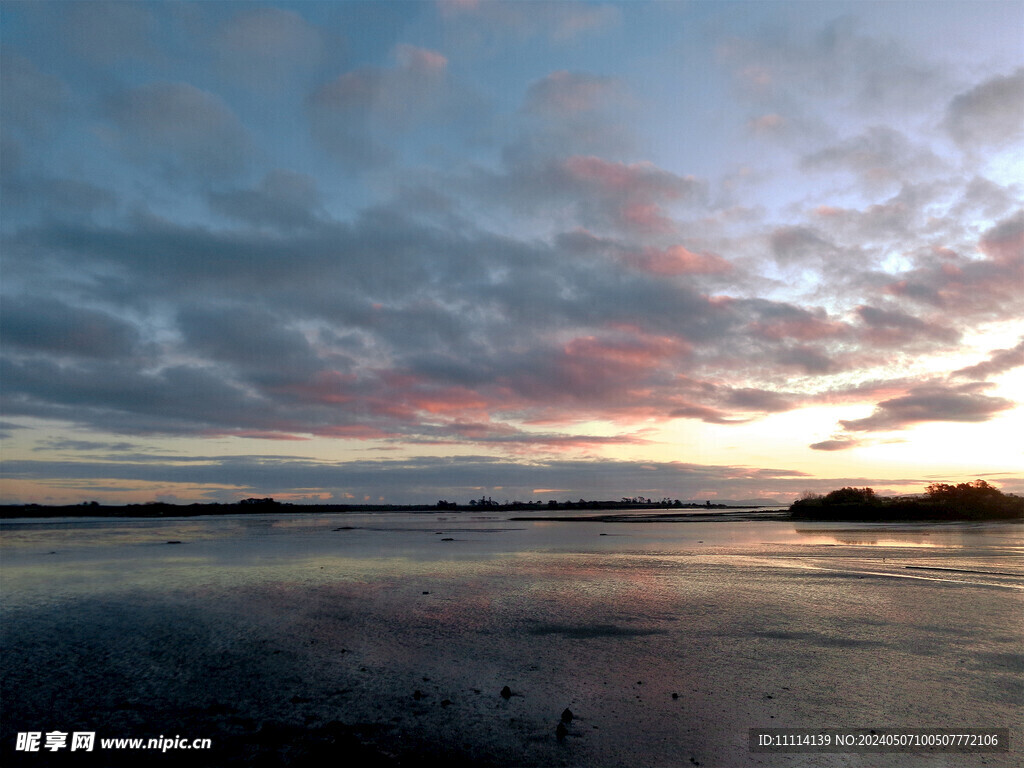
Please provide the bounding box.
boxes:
[0,456,815,504]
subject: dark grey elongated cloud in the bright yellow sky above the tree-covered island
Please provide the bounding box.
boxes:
[840,384,1014,432]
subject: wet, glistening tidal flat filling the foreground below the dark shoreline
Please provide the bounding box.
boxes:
[0,511,1024,767]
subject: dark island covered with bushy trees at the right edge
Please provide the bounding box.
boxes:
[790,480,1024,522]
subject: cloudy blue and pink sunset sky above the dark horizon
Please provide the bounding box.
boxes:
[0,0,1024,504]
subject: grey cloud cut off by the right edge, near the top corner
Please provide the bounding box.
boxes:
[942,68,1024,148]
